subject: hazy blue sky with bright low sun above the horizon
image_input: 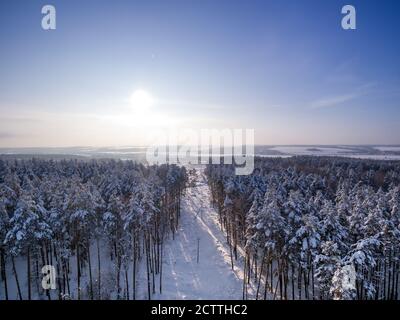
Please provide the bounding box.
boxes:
[0,0,400,147]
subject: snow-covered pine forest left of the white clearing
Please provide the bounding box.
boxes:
[0,159,187,300]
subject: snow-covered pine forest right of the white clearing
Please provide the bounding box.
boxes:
[206,157,400,299]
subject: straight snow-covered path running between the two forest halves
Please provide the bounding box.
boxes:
[142,169,252,300]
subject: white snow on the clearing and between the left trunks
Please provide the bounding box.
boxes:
[0,167,270,300]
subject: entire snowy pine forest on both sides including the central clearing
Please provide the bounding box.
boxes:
[0,156,400,300]
